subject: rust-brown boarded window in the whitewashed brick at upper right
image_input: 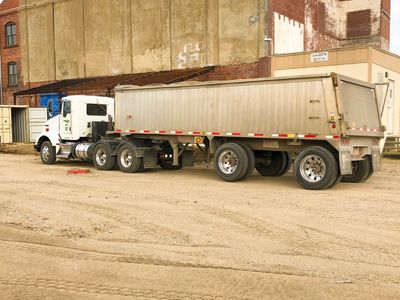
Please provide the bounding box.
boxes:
[347,9,371,38]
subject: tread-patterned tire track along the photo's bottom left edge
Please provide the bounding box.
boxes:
[0,277,231,300]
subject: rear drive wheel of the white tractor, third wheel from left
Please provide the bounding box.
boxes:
[117,143,143,173]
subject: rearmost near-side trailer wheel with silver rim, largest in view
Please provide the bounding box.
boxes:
[294,146,339,190]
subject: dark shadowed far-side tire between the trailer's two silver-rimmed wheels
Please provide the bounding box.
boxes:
[256,151,292,177]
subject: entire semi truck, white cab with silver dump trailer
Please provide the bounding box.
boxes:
[35,73,385,190]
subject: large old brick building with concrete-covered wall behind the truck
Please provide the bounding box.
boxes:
[0,0,390,105]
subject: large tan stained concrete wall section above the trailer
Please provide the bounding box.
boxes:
[20,0,265,82]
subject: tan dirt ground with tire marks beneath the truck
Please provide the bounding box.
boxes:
[0,154,400,299]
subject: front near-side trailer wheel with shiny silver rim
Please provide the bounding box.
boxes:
[214,143,249,182]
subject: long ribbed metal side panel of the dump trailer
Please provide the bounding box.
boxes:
[116,77,335,134]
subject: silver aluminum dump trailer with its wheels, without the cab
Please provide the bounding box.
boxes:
[108,74,385,189]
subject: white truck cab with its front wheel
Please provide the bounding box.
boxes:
[35,96,114,163]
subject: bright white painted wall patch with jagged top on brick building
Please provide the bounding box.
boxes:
[274,12,304,54]
